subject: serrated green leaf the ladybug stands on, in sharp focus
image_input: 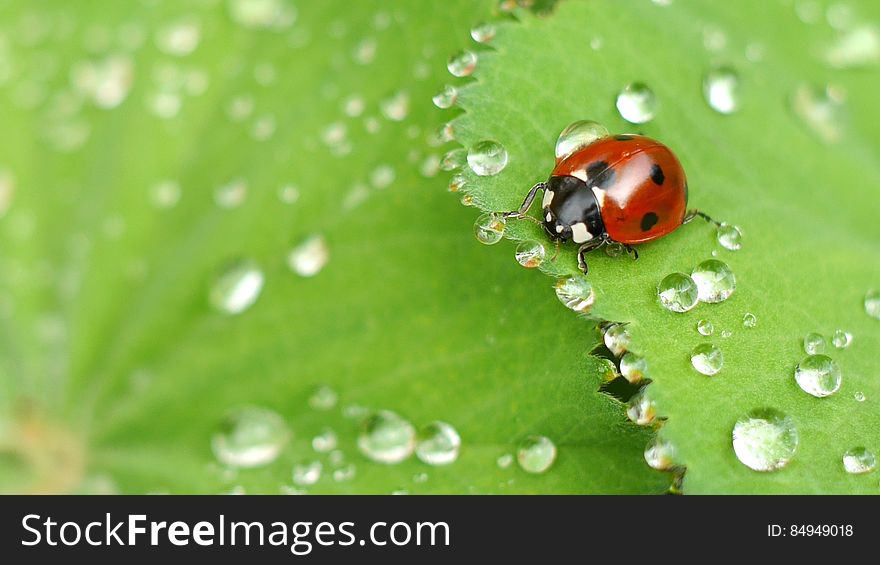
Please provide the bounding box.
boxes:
[454,0,880,493]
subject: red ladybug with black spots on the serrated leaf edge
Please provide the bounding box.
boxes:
[503,135,718,273]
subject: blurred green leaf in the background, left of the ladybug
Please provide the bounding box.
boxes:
[0,0,669,493]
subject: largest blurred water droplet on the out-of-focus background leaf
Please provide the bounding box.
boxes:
[211,407,290,467]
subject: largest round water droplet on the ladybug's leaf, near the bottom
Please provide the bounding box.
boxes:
[733,408,798,472]
